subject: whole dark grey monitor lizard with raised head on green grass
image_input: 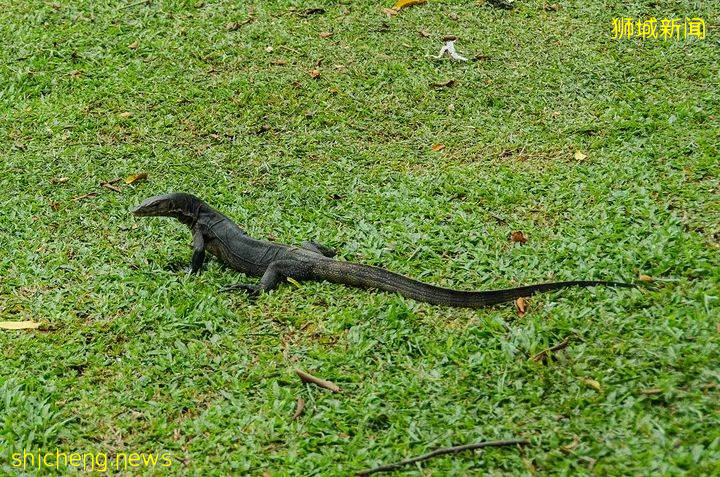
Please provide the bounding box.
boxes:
[132,193,634,308]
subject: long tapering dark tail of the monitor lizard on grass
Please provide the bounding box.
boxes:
[312,260,635,308]
